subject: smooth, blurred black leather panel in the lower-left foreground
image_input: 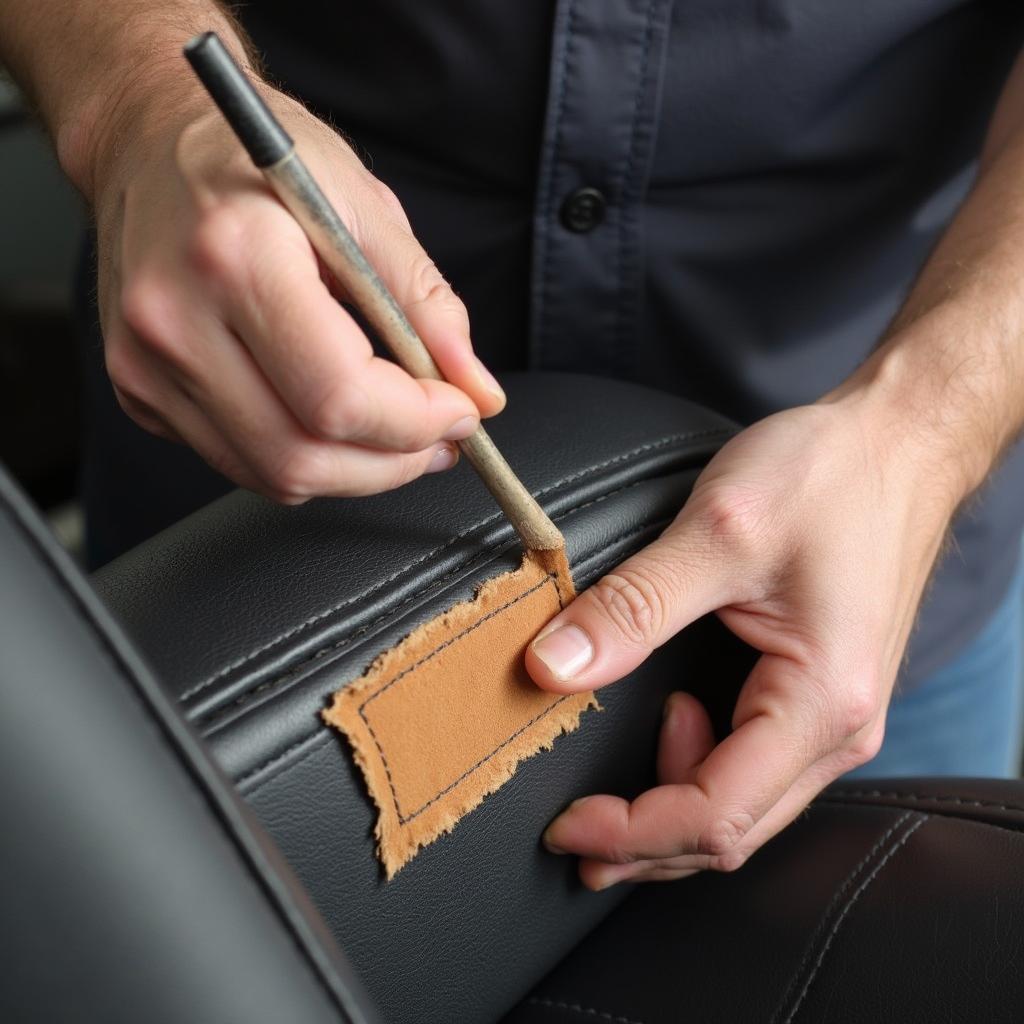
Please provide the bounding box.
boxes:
[0,470,377,1024]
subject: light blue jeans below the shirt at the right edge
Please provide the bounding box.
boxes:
[845,566,1024,778]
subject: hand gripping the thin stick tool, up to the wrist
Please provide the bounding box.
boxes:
[93,86,505,504]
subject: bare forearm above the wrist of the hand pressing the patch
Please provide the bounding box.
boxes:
[828,51,1024,502]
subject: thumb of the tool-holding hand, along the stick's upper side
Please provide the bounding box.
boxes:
[360,192,505,416]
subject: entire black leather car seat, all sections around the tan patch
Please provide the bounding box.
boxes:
[0,376,1024,1024]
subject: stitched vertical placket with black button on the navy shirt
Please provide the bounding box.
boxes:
[530,0,672,376]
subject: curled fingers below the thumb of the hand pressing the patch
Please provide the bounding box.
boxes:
[545,655,881,885]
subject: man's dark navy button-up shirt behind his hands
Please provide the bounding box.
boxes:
[86,0,1024,685]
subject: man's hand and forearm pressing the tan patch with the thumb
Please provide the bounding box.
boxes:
[526,44,1024,889]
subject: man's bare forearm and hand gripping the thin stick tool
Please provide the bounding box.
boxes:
[0,0,504,502]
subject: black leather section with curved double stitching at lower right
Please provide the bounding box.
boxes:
[506,779,1024,1024]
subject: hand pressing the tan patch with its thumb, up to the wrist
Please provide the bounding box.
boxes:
[526,395,957,889]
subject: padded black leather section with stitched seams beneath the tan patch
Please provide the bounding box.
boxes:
[95,376,748,1024]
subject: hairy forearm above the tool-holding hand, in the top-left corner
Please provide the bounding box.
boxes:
[0,0,249,200]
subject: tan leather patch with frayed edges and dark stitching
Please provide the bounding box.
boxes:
[324,551,598,879]
